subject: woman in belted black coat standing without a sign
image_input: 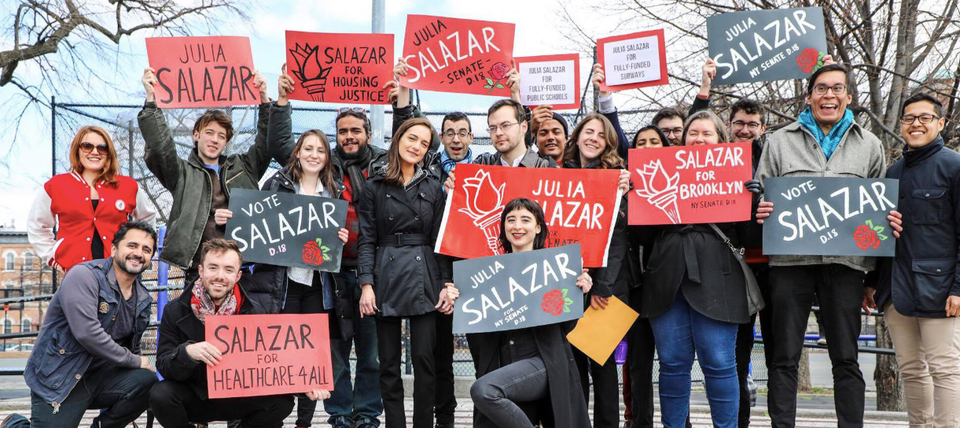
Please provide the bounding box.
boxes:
[357,118,453,428]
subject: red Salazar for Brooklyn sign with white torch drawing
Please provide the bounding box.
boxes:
[627,143,753,225]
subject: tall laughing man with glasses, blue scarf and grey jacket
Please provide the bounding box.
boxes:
[756,64,902,427]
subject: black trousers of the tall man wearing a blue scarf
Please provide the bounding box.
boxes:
[764,264,866,428]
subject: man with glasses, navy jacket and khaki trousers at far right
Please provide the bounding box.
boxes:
[864,93,960,427]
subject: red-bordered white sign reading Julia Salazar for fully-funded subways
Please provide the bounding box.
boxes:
[597,29,670,92]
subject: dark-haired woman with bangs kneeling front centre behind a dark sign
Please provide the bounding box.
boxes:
[445,198,593,428]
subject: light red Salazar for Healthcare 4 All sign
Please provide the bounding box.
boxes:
[204,314,333,398]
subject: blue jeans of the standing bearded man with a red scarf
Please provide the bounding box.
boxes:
[323,269,383,426]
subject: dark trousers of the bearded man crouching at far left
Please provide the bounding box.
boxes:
[29,365,158,428]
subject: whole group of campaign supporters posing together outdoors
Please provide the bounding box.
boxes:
[3,46,960,428]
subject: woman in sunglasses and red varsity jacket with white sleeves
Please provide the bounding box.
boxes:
[27,126,156,274]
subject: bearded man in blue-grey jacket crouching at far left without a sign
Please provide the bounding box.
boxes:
[0,221,157,428]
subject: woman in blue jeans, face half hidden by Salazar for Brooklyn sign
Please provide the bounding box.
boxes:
[640,111,751,428]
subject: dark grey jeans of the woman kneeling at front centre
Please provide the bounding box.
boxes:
[470,357,548,428]
